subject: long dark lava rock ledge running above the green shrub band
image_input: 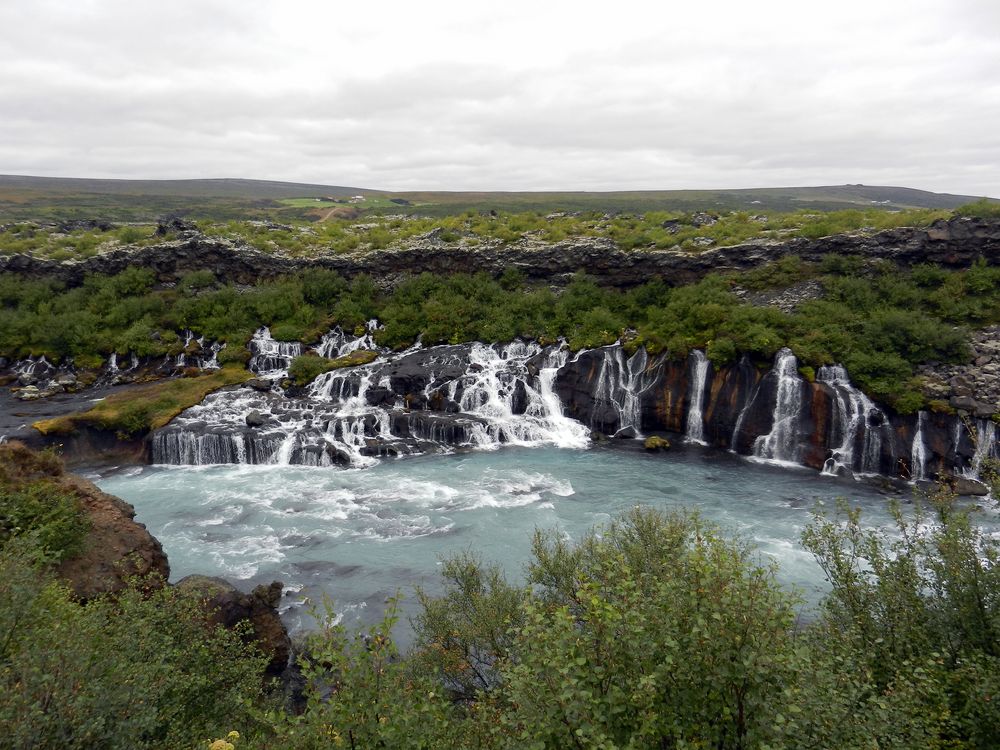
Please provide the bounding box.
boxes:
[0,218,1000,288]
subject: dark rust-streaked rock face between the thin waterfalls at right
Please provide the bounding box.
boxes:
[555,347,995,488]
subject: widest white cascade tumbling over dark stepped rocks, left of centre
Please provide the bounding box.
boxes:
[152,334,589,467]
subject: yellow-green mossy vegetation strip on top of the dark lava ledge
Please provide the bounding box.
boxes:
[0,203,1000,260]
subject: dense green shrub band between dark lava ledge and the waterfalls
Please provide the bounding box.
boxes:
[0,255,1000,412]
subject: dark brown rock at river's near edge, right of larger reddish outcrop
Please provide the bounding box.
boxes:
[175,575,292,675]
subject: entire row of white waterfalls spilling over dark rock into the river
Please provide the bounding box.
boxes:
[139,328,996,488]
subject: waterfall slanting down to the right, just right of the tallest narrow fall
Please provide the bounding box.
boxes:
[816,365,886,475]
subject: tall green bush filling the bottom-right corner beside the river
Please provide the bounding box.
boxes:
[804,490,1000,748]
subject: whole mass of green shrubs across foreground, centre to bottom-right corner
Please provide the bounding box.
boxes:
[280,496,1000,750]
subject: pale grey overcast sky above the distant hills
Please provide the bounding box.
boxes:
[0,0,1000,197]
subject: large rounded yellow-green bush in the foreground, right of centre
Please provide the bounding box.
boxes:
[503,510,796,747]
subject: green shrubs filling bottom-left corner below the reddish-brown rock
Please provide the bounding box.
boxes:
[0,544,265,750]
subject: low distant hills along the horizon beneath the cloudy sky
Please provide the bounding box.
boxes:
[0,175,978,222]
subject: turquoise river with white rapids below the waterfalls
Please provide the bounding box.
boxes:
[93,441,928,642]
